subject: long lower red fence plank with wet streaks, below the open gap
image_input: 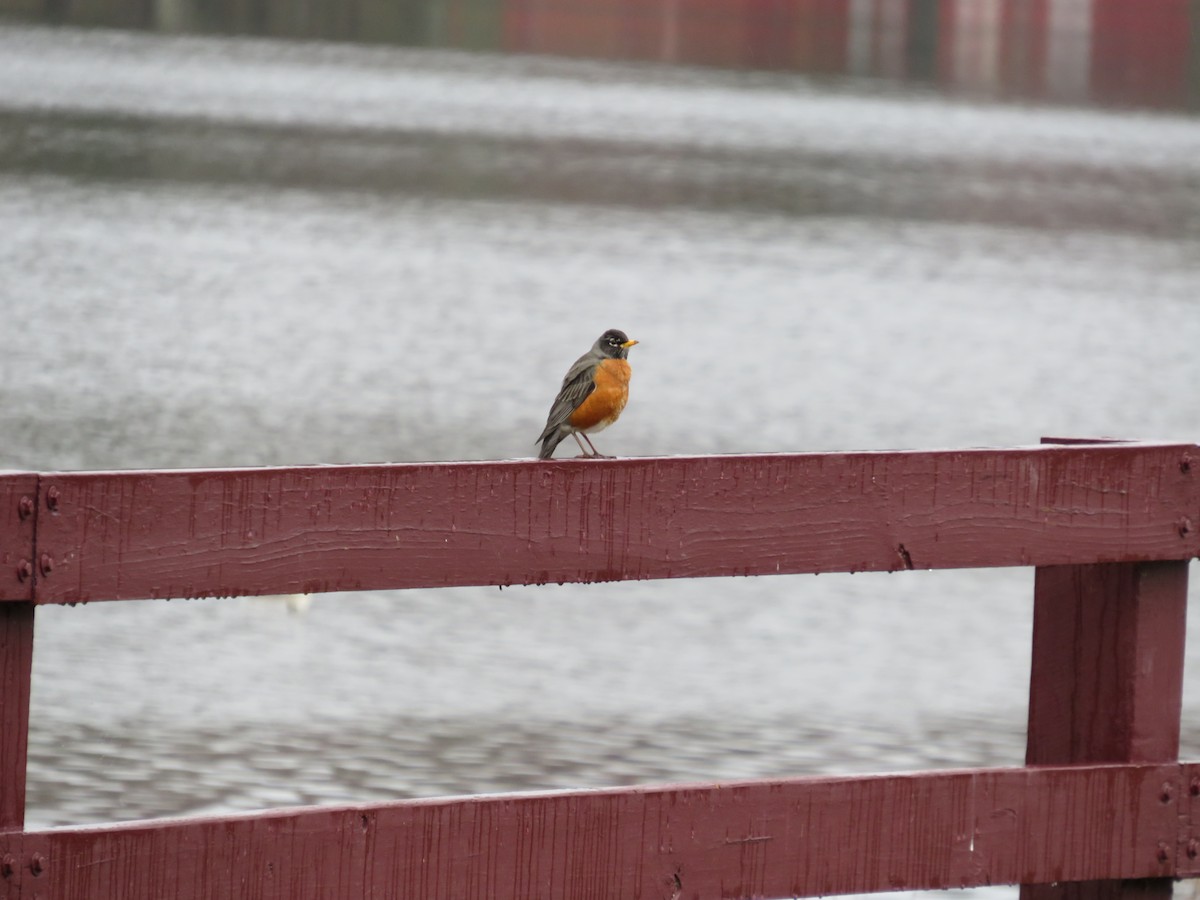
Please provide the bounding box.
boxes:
[0,766,1182,900]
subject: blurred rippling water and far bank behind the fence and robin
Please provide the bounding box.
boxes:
[0,0,1200,893]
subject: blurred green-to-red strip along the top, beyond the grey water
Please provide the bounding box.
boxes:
[0,0,1200,109]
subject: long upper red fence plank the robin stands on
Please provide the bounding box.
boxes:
[28,444,1200,602]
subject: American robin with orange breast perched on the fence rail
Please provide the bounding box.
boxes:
[535,328,637,460]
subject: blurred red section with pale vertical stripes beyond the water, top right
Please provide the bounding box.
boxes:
[499,0,1200,107]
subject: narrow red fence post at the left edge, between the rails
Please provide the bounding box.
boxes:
[0,601,34,832]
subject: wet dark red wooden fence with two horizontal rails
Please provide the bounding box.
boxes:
[0,444,1200,900]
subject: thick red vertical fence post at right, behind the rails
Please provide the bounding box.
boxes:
[1021,560,1188,900]
